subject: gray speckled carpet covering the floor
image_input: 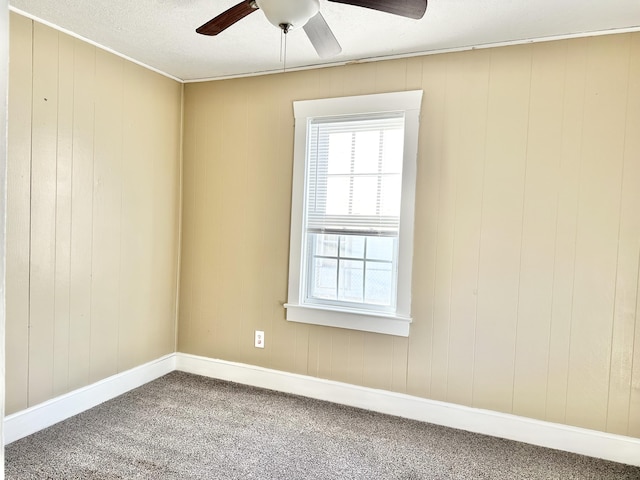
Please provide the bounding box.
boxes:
[5,372,640,480]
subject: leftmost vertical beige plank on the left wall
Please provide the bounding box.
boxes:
[5,15,33,414]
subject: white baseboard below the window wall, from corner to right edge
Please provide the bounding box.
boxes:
[176,353,640,466]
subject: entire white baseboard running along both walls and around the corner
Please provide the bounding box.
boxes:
[4,353,640,466]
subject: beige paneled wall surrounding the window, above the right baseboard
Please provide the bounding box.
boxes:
[178,33,640,437]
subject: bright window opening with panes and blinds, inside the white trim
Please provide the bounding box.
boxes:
[305,113,404,309]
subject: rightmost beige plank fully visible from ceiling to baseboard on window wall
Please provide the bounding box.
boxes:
[566,36,630,430]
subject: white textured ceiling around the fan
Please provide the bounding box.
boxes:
[9,0,640,81]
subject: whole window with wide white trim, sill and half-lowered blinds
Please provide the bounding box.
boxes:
[285,91,422,336]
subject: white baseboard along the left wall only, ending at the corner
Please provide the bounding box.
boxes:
[4,353,176,445]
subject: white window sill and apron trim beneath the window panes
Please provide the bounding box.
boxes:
[284,303,411,337]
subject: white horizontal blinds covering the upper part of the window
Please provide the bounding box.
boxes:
[306,112,404,236]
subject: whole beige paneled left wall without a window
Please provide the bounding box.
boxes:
[6,14,182,413]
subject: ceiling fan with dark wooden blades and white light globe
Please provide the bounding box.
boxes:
[196,0,427,58]
